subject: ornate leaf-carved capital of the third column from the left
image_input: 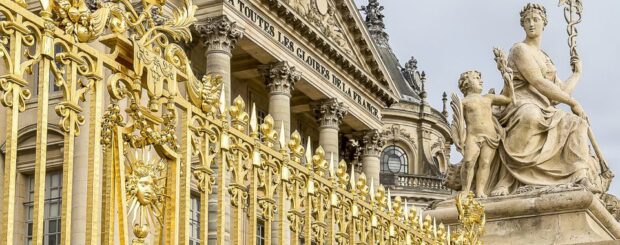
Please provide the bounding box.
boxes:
[311,98,349,129]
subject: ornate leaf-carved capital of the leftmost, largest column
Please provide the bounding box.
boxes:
[196,15,245,55]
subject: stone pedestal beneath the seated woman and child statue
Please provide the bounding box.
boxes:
[424,190,620,244]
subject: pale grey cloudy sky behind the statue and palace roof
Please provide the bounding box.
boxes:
[355,0,620,196]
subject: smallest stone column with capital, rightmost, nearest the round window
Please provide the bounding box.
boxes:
[361,130,384,183]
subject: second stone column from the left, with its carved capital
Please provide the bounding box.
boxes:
[258,61,301,142]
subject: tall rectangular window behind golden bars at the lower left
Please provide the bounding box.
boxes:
[24,171,62,245]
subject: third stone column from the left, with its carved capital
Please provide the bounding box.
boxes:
[312,98,348,166]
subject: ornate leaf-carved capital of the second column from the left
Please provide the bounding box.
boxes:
[258,61,301,97]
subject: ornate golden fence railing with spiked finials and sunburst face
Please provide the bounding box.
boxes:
[0,0,484,244]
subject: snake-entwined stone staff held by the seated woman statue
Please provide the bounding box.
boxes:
[559,0,611,177]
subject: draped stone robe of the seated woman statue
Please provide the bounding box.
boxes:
[487,44,598,192]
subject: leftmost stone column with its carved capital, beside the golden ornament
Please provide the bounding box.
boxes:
[196,15,244,105]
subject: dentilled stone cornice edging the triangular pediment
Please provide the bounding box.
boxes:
[261,0,398,106]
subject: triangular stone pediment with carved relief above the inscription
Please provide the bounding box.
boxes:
[262,0,400,106]
